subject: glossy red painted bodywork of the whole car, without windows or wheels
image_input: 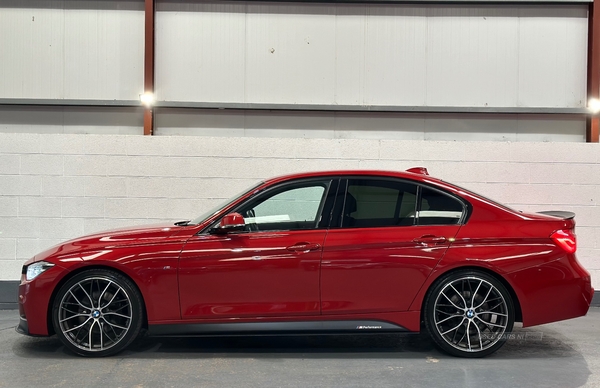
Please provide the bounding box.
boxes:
[19,170,593,336]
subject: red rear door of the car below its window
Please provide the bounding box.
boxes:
[321,225,460,314]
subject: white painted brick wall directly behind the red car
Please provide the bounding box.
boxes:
[0,133,600,288]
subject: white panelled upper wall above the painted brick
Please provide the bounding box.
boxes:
[0,0,588,142]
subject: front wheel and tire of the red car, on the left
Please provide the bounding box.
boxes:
[52,269,143,357]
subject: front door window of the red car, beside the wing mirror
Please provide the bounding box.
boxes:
[238,182,328,231]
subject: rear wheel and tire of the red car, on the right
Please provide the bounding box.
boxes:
[423,270,515,358]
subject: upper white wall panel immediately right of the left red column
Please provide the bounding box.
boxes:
[155,2,246,102]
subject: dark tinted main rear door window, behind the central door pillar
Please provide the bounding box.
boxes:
[342,179,417,228]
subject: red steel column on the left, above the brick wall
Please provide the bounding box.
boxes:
[144,0,155,135]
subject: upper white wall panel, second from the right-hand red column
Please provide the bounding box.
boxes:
[426,6,520,107]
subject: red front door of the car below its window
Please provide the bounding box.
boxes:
[179,230,326,319]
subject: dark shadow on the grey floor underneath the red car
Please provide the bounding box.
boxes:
[13,328,582,359]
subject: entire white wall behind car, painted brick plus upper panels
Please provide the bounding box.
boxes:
[0,0,600,302]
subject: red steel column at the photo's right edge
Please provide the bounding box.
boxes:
[586,0,600,143]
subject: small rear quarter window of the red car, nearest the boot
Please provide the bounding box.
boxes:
[417,187,464,225]
